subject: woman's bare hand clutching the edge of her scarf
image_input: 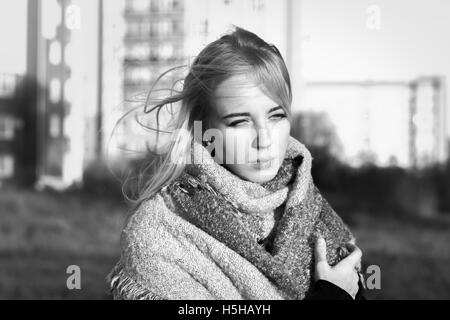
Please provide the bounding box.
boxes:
[315,237,362,299]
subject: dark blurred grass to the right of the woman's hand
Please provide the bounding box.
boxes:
[352,211,450,299]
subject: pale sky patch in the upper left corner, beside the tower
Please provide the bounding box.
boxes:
[0,0,27,74]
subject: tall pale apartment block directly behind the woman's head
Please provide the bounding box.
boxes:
[112,0,301,155]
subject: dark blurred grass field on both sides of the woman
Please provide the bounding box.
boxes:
[0,190,450,299]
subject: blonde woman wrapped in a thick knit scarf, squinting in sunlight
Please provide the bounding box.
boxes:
[108,28,361,300]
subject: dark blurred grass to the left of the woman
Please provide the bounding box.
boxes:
[0,190,126,299]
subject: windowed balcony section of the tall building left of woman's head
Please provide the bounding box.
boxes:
[124,0,185,97]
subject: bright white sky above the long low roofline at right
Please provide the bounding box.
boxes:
[301,0,450,80]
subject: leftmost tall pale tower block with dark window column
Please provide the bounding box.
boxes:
[26,0,101,189]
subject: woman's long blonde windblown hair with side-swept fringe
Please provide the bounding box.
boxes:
[121,27,292,208]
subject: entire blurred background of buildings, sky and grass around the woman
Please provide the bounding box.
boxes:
[0,0,450,299]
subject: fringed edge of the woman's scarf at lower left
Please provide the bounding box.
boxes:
[106,266,164,300]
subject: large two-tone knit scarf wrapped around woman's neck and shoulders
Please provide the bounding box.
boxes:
[108,137,354,299]
